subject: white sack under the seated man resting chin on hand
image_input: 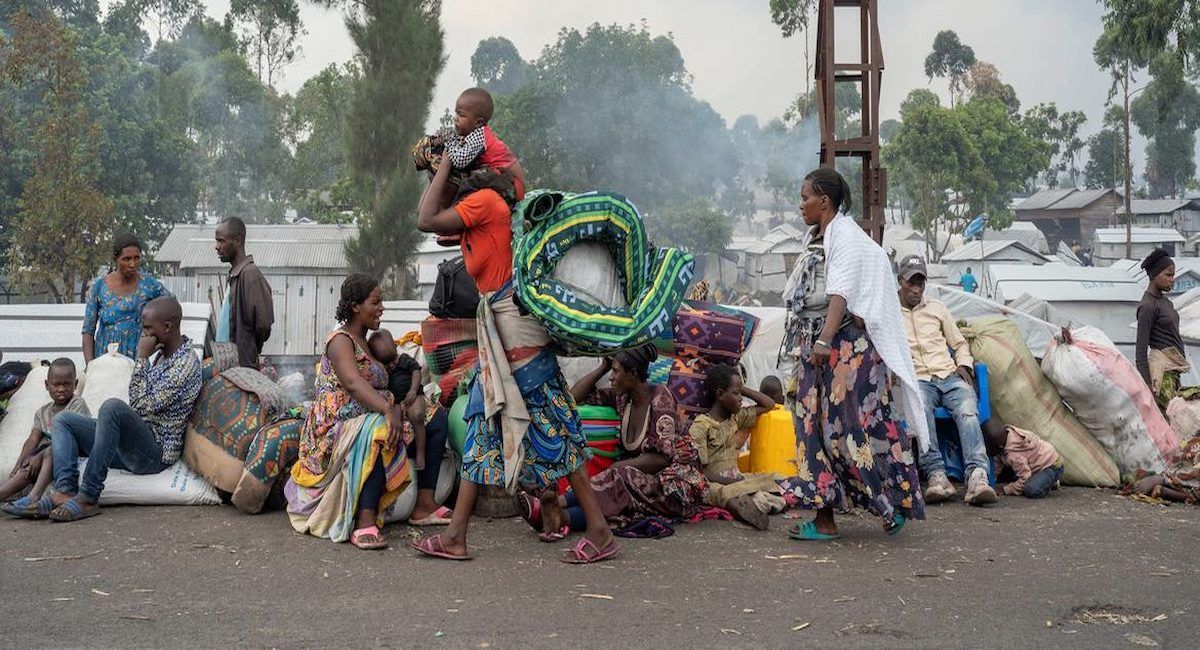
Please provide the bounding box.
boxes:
[79,458,221,506]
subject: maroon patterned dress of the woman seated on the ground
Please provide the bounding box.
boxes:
[592,386,708,526]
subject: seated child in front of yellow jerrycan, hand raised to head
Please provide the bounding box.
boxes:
[689,365,785,530]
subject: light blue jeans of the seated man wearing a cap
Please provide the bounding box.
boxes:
[917,374,988,477]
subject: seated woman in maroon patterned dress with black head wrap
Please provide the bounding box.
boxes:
[521,344,708,542]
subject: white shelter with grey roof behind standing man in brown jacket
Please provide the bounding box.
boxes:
[154,224,359,355]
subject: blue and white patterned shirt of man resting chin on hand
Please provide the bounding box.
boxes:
[130,336,202,465]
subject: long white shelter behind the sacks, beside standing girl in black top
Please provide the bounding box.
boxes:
[982,263,1146,343]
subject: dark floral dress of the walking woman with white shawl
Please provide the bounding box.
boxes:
[780,245,925,520]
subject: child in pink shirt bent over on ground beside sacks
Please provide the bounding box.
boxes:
[983,416,1062,499]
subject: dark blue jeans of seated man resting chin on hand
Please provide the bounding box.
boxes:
[50,398,170,502]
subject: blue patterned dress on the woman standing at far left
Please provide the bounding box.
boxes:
[83,273,170,359]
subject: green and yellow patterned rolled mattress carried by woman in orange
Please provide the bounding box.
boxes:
[512,191,695,356]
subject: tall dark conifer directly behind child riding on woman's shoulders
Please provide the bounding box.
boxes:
[321,0,445,296]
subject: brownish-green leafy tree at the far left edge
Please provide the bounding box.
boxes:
[0,10,113,302]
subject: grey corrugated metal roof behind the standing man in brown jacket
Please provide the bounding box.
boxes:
[154,224,359,270]
